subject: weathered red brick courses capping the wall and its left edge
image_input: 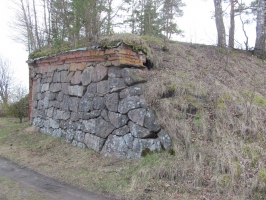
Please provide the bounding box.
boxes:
[28,44,146,120]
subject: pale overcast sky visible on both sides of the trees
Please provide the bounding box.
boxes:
[0,0,256,88]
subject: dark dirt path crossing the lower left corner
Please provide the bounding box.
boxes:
[0,157,118,200]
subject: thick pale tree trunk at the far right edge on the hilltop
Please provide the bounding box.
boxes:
[254,0,266,59]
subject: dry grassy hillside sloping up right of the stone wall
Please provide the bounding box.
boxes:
[142,39,266,199]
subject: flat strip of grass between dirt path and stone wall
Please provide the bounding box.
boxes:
[0,118,220,199]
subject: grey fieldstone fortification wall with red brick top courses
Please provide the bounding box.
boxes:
[28,44,171,158]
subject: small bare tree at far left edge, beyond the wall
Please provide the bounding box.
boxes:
[0,56,13,105]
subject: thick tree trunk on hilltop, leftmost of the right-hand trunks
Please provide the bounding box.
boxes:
[213,0,226,48]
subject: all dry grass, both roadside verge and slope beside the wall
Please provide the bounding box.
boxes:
[0,41,266,199]
